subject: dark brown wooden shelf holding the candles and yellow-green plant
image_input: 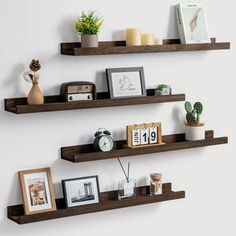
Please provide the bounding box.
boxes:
[61,38,230,56]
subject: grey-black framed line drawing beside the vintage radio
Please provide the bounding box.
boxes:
[106,67,147,98]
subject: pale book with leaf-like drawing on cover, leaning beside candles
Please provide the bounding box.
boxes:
[176,4,211,44]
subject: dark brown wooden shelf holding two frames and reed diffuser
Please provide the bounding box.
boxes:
[7,183,185,224]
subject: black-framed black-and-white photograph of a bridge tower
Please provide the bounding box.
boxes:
[62,176,100,207]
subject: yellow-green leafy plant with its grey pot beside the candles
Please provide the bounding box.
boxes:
[75,11,103,48]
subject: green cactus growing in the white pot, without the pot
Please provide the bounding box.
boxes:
[185,102,203,126]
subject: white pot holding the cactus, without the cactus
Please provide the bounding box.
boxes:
[185,125,205,141]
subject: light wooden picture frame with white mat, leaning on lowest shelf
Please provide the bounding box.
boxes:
[18,168,56,215]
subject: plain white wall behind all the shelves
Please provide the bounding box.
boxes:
[0,0,236,236]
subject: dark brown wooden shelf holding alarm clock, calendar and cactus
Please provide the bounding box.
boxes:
[61,131,228,162]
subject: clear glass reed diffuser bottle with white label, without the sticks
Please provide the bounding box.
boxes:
[118,179,136,200]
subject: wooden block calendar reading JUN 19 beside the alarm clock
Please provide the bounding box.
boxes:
[127,123,164,148]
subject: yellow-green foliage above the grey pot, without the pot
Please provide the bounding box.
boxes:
[75,11,103,35]
